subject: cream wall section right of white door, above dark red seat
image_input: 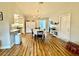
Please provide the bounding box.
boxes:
[70,12,79,44]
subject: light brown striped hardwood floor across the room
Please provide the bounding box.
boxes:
[0,34,77,56]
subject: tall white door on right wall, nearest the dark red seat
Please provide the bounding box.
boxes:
[60,14,70,41]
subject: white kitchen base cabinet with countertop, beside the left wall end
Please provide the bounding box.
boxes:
[10,29,21,45]
